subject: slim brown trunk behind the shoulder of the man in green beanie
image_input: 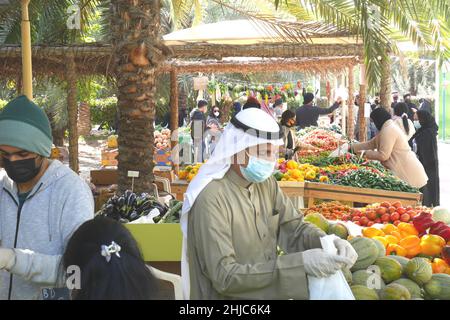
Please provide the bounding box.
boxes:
[66,56,79,173]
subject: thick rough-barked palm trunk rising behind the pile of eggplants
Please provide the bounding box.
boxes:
[111,0,164,192]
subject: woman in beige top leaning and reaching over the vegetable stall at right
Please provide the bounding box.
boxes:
[351,108,428,188]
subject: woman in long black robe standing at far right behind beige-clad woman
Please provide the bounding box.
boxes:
[411,110,440,207]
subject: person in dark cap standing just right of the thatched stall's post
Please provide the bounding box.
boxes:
[191,100,208,162]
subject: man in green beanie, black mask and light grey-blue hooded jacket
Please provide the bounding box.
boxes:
[0,96,94,300]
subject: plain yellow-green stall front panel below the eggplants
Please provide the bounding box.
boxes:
[125,223,183,262]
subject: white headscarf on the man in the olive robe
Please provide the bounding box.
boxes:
[180,108,283,299]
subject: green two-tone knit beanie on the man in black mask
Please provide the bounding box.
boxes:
[0,96,53,158]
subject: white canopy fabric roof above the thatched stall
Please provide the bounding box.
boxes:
[163,19,361,46]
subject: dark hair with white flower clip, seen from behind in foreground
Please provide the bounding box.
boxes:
[63,216,157,300]
